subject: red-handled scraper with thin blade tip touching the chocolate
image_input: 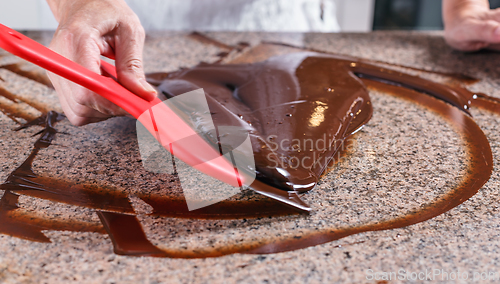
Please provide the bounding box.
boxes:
[0,24,311,211]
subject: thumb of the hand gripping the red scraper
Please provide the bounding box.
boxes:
[115,25,156,101]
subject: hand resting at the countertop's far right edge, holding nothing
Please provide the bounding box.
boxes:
[443,0,500,51]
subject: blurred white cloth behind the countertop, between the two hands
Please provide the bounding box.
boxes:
[126,0,340,32]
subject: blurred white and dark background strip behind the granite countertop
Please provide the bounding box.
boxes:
[0,0,500,32]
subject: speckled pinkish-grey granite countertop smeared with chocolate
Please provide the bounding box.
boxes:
[0,32,500,283]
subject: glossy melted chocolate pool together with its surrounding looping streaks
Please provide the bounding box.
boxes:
[0,43,500,258]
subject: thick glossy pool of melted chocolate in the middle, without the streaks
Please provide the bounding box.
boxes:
[159,53,372,192]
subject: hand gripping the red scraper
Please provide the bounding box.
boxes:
[47,0,156,126]
